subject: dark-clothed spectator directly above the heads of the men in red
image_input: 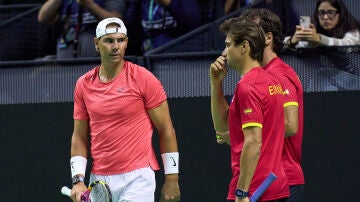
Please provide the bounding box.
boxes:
[224,0,299,35]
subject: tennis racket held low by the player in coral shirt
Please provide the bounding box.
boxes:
[61,180,112,202]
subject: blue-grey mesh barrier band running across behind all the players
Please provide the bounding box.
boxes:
[0,47,360,104]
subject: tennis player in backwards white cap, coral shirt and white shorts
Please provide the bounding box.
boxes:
[70,18,180,202]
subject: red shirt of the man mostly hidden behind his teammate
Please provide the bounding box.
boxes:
[264,58,305,185]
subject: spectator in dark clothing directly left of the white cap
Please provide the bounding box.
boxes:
[38,0,126,59]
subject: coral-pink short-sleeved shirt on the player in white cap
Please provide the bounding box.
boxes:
[74,61,166,175]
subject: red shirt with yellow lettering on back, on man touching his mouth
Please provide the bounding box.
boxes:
[227,67,289,201]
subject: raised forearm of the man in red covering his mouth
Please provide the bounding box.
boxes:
[211,83,229,132]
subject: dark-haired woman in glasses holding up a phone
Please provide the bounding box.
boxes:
[284,0,360,49]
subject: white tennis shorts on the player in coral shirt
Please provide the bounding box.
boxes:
[90,167,156,202]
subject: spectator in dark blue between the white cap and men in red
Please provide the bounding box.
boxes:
[141,0,202,53]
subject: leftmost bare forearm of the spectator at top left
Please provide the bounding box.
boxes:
[38,0,62,24]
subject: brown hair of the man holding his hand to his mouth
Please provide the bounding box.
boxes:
[220,17,265,62]
